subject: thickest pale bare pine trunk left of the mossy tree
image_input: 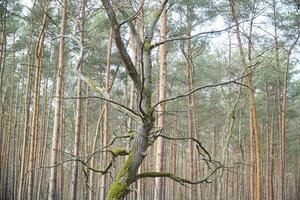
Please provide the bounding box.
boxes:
[48,0,67,200]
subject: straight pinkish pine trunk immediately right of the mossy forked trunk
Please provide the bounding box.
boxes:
[154,4,167,200]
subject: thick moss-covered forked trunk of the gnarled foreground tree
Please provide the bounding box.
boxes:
[101,0,167,200]
